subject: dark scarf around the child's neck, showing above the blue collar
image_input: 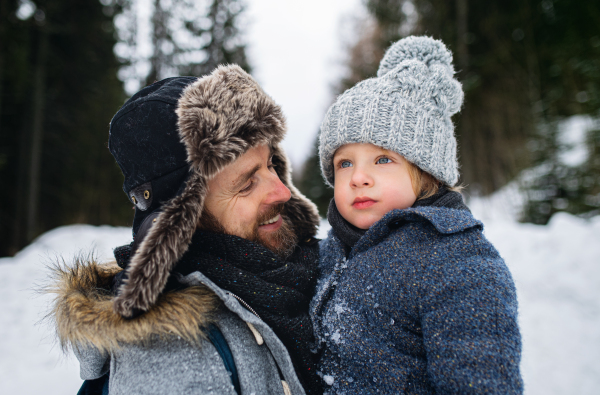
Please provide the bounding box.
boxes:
[327,187,469,252]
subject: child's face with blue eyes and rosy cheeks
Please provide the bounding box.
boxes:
[333,144,417,229]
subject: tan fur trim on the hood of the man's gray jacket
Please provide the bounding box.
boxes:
[46,260,220,352]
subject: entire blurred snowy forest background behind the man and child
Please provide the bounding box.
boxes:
[0,0,600,394]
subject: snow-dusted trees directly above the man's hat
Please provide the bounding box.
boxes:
[113,0,250,91]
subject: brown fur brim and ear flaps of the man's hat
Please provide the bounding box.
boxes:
[113,65,319,317]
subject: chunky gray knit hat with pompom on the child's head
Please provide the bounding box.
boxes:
[319,37,464,186]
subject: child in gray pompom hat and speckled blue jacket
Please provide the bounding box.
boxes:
[311,37,523,395]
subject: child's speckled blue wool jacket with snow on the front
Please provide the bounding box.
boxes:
[311,207,523,395]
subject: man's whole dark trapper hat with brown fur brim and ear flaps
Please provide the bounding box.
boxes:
[110,65,319,317]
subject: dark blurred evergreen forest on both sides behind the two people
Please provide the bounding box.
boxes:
[0,0,600,256]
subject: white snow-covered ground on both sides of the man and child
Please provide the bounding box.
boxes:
[0,198,600,395]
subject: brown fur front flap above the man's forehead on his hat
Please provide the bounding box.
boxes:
[177,65,285,179]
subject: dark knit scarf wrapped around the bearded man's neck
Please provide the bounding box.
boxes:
[174,231,322,394]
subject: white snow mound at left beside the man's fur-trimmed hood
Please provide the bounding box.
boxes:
[0,225,131,395]
